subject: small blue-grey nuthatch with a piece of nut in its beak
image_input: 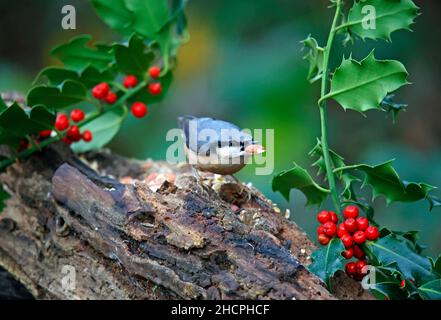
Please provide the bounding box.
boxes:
[178,116,265,175]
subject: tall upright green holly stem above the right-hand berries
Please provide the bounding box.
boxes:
[319,0,342,214]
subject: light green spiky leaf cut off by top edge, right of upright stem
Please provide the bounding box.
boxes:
[343,0,419,41]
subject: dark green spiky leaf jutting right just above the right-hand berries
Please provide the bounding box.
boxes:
[337,160,435,203]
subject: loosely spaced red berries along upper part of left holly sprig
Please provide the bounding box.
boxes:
[92,66,162,118]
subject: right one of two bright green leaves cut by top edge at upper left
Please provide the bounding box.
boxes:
[125,0,170,39]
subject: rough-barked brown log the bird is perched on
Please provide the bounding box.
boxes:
[0,145,370,299]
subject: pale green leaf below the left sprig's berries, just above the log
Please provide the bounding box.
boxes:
[72,105,127,152]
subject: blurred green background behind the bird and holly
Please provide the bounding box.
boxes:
[0,0,441,255]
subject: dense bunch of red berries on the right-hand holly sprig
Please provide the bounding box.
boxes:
[317,206,380,280]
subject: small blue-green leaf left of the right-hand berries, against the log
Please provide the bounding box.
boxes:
[308,238,345,287]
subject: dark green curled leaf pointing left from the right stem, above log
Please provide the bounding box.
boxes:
[272,163,330,205]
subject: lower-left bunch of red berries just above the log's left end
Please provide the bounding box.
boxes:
[54,109,92,145]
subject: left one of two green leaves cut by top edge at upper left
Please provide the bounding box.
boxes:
[91,0,134,36]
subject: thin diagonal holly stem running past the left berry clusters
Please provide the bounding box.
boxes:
[0,81,147,171]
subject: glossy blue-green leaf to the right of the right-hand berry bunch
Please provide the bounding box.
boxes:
[364,234,439,285]
